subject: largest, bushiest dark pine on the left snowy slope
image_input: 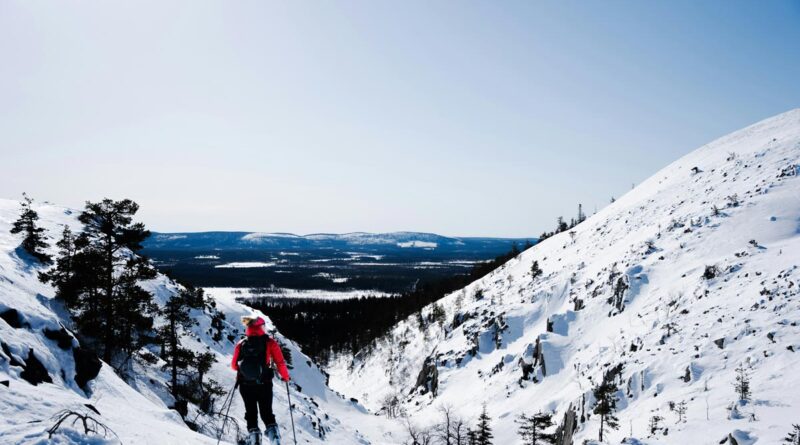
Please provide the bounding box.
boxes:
[40,199,157,365]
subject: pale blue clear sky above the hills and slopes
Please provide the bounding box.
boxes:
[0,0,800,236]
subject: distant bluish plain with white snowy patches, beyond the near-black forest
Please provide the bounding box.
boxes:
[143,232,535,294]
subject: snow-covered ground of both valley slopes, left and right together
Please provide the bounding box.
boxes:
[0,109,800,445]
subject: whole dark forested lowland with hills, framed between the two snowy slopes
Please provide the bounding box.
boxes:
[144,232,536,365]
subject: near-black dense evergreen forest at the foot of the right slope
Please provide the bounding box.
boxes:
[242,243,532,364]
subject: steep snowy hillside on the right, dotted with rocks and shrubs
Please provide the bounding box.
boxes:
[330,110,800,445]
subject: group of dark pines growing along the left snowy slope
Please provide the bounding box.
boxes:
[11,195,224,416]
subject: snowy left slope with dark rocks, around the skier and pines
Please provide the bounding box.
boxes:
[0,200,392,444]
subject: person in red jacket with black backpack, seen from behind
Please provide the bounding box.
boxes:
[231,316,289,443]
